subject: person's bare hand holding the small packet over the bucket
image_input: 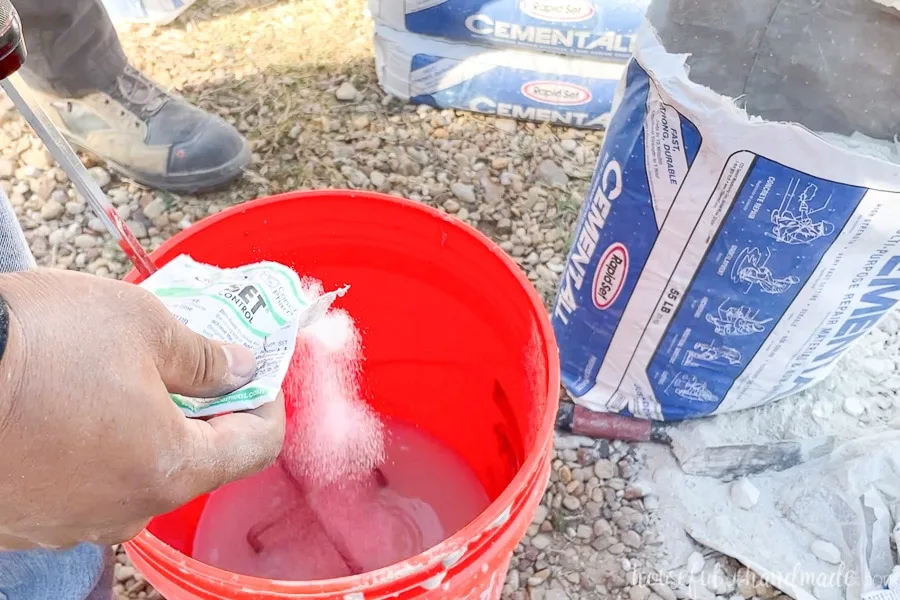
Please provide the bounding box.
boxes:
[0,269,284,549]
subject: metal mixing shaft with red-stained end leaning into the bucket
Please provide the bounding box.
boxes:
[0,0,156,277]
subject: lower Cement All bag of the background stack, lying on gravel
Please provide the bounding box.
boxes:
[375,27,625,129]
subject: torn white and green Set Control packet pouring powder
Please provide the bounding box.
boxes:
[140,254,347,417]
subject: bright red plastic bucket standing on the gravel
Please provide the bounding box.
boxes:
[119,191,559,600]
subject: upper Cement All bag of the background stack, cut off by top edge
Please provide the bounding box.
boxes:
[369,0,650,61]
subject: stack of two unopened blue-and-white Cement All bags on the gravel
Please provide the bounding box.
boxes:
[369,0,650,129]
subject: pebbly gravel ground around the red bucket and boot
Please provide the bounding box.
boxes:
[0,0,778,600]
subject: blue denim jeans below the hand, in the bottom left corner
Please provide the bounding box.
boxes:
[0,544,113,600]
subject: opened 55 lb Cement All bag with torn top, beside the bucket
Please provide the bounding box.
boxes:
[553,21,900,420]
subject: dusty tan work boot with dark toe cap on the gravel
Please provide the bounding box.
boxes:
[35,66,250,193]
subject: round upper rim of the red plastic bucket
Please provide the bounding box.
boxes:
[123,188,560,595]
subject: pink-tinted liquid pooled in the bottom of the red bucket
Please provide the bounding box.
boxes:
[193,419,490,581]
